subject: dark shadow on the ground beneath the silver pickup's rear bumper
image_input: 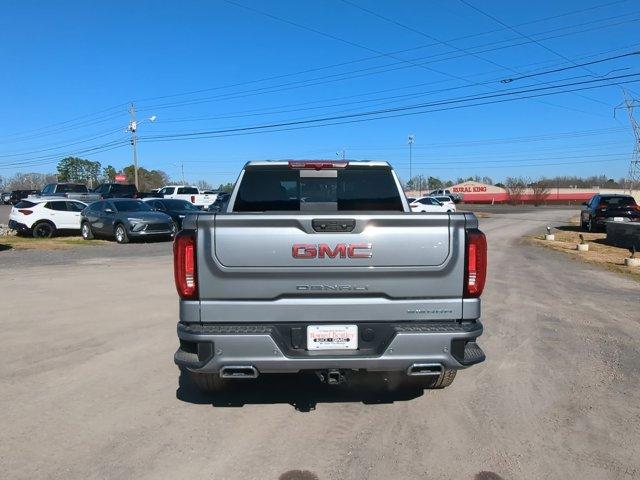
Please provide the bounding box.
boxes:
[176,373,423,412]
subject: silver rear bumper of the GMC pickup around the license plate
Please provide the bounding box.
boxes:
[174,321,485,373]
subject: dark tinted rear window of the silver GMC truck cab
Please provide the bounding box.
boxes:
[233,165,403,212]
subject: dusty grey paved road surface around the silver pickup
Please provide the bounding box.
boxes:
[0,210,640,480]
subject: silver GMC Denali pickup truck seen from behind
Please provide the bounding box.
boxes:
[174,161,487,391]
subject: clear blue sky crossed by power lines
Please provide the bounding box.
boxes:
[0,0,640,185]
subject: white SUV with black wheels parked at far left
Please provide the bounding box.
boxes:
[9,198,87,238]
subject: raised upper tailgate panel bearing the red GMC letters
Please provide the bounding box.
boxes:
[212,214,451,266]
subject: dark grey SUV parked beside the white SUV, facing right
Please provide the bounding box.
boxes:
[80,198,176,243]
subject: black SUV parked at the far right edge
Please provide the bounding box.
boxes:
[580,195,640,232]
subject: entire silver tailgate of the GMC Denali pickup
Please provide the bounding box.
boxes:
[193,213,477,322]
